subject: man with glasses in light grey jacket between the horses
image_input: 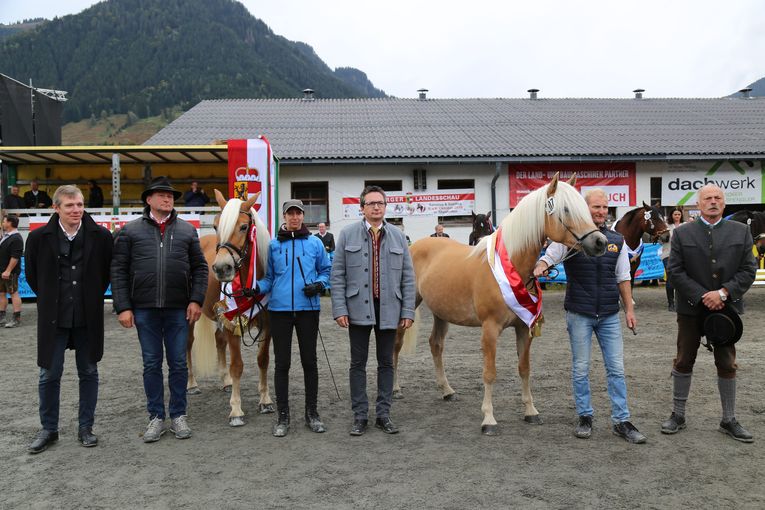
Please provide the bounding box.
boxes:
[330,186,415,436]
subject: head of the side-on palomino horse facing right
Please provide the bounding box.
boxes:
[542,174,607,257]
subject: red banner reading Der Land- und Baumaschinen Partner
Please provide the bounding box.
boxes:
[508,162,636,207]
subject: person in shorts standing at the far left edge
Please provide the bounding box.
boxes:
[0,214,24,328]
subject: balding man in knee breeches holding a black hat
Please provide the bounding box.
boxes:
[661,184,756,443]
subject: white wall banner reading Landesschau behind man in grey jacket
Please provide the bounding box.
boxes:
[343,189,475,219]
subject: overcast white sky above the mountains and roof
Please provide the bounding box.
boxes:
[0,0,765,98]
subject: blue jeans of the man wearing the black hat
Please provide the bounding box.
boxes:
[133,308,189,419]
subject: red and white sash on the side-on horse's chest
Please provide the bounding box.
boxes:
[486,227,542,329]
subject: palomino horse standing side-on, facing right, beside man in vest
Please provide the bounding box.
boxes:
[394,174,606,435]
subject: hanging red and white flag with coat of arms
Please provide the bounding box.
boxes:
[228,136,279,237]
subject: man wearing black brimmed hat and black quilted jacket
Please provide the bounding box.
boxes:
[112,176,207,443]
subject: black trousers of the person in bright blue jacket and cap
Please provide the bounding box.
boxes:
[269,310,319,411]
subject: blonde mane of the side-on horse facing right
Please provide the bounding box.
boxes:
[470,181,592,258]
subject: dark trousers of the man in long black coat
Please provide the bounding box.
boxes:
[38,328,98,432]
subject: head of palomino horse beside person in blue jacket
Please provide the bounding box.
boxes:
[211,189,267,282]
